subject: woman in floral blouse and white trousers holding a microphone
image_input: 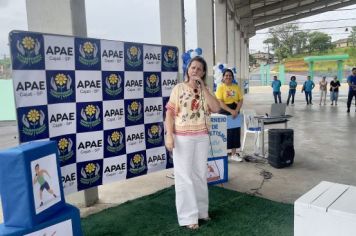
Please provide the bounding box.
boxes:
[165,57,220,229]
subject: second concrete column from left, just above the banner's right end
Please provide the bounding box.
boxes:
[159,0,185,78]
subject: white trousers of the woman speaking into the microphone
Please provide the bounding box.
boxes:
[173,134,209,226]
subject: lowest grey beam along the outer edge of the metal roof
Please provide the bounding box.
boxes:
[254,1,355,30]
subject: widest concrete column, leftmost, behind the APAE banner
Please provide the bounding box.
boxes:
[26,0,99,206]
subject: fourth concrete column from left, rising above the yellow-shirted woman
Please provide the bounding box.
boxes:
[214,0,227,63]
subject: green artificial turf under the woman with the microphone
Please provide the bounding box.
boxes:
[82,186,293,236]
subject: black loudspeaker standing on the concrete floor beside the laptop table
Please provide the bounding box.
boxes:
[268,129,295,168]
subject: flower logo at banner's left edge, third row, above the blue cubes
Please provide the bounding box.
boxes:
[22,109,47,136]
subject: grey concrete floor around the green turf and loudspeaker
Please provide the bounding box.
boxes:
[0,84,356,222]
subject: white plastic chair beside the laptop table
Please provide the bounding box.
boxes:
[241,110,268,153]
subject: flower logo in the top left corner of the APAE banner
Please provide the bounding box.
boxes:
[16,36,42,66]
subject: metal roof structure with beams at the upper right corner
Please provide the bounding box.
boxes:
[225,0,356,37]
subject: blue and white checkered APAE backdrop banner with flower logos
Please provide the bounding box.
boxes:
[9,31,178,194]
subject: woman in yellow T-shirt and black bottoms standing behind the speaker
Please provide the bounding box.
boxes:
[215,69,243,161]
